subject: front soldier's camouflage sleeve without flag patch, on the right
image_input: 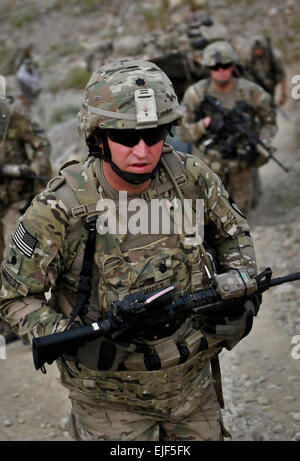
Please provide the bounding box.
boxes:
[187,156,256,276]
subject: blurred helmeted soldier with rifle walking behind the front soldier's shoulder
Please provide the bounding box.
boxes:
[178,41,276,213]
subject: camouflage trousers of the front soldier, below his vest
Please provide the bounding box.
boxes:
[70,385,224,441]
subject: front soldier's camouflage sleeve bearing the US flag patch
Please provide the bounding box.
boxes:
[0,187,68,341]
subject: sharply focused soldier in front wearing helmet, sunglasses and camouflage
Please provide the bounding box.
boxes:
[0,60,260,441]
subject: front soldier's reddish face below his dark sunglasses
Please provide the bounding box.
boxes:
[107,137,164,174]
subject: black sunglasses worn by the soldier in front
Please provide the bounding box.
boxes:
[107,125,169,147]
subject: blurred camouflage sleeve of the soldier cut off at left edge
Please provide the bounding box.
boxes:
[14,113,51,176]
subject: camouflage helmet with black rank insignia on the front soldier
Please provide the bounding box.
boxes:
[78,59,182,138]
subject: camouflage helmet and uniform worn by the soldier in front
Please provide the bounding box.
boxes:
[0,61,256,441]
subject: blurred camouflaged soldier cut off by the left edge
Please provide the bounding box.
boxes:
[0,76,51,342]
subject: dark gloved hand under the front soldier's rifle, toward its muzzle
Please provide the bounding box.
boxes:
[202,294,261,350]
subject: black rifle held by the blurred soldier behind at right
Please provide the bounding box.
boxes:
[198,95,289,173]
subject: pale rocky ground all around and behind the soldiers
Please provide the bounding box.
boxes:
[0,0,300,441]
